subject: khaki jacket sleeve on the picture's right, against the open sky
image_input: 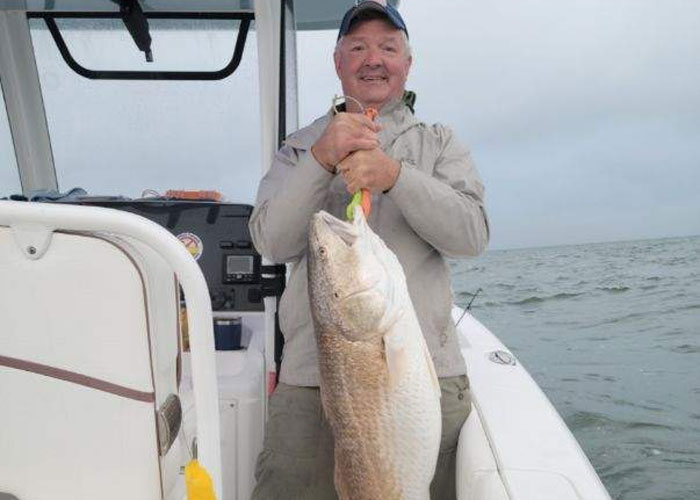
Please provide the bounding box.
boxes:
[387,125,489,257]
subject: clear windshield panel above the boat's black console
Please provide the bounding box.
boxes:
[30,19,260,203]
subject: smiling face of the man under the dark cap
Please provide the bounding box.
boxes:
[333,19,411,109]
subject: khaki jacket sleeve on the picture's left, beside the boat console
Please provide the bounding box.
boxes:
[249,144,333,263]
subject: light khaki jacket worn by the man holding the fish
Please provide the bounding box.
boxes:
[250,99,489,386]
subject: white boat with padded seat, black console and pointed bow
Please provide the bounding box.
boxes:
[0,0,610,500]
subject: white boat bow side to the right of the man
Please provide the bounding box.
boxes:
[454,308,610,500]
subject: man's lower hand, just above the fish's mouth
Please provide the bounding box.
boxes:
[338,148,401,193]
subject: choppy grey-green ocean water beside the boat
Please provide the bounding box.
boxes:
[450,237,700,500]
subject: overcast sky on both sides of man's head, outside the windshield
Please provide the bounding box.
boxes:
[298,0,700,248]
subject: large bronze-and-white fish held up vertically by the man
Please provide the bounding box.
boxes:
[308,207,441,500]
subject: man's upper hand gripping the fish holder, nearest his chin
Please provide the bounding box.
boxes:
[311,113,380,172]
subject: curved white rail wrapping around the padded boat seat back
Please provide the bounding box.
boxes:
[0,201,222,498]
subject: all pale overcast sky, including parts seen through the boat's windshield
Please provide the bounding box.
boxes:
[0,0,700,249]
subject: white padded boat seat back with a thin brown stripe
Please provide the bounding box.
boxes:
[0,206,189,500]
